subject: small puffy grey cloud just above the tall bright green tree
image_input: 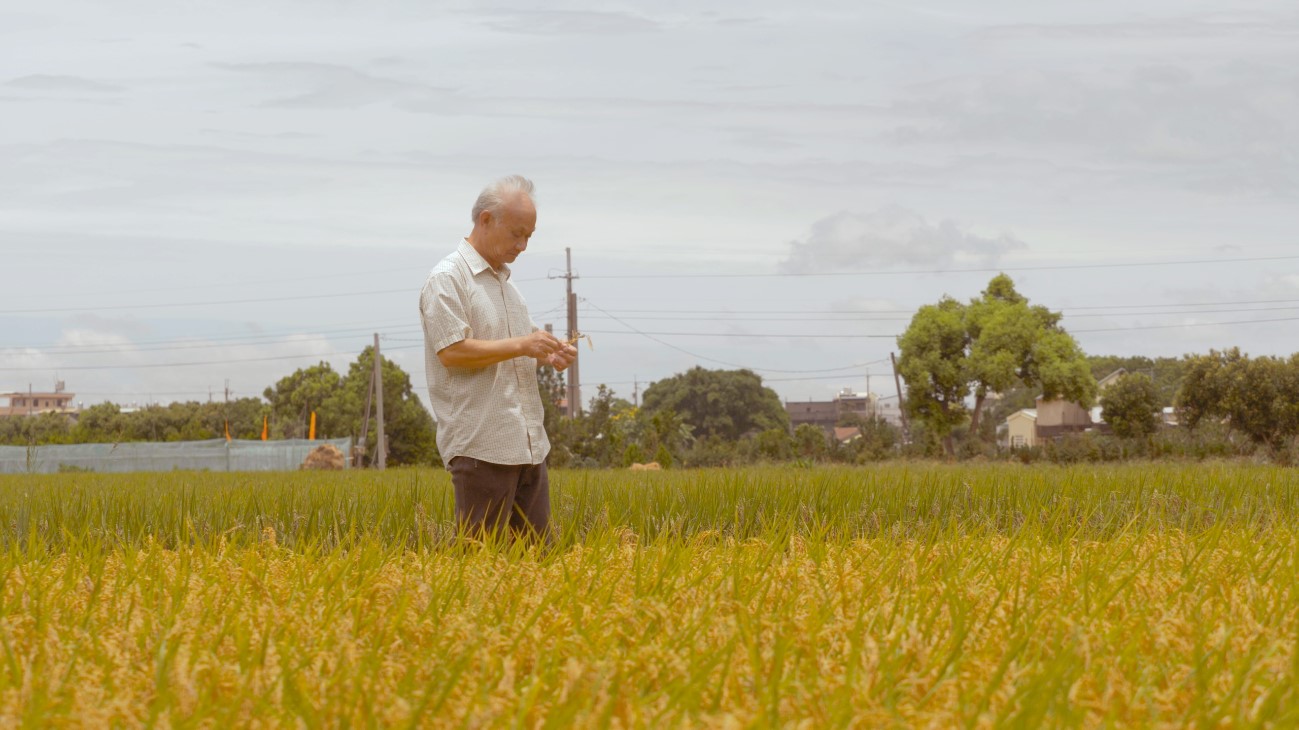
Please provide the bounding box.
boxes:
[779,205,1025,274]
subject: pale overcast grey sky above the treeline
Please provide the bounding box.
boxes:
[0,0,1299,413]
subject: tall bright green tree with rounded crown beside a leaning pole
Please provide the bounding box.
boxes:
[898,274,1096,453]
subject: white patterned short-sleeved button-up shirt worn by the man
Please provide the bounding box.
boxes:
[420,240,551,465]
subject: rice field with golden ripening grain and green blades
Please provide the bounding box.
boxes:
[0,464,1299,727]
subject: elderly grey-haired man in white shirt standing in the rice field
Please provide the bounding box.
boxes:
[420,175,577,538]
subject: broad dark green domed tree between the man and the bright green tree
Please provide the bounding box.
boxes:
[643,368,790,440]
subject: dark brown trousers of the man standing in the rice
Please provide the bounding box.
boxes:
[449,456,551,540]
